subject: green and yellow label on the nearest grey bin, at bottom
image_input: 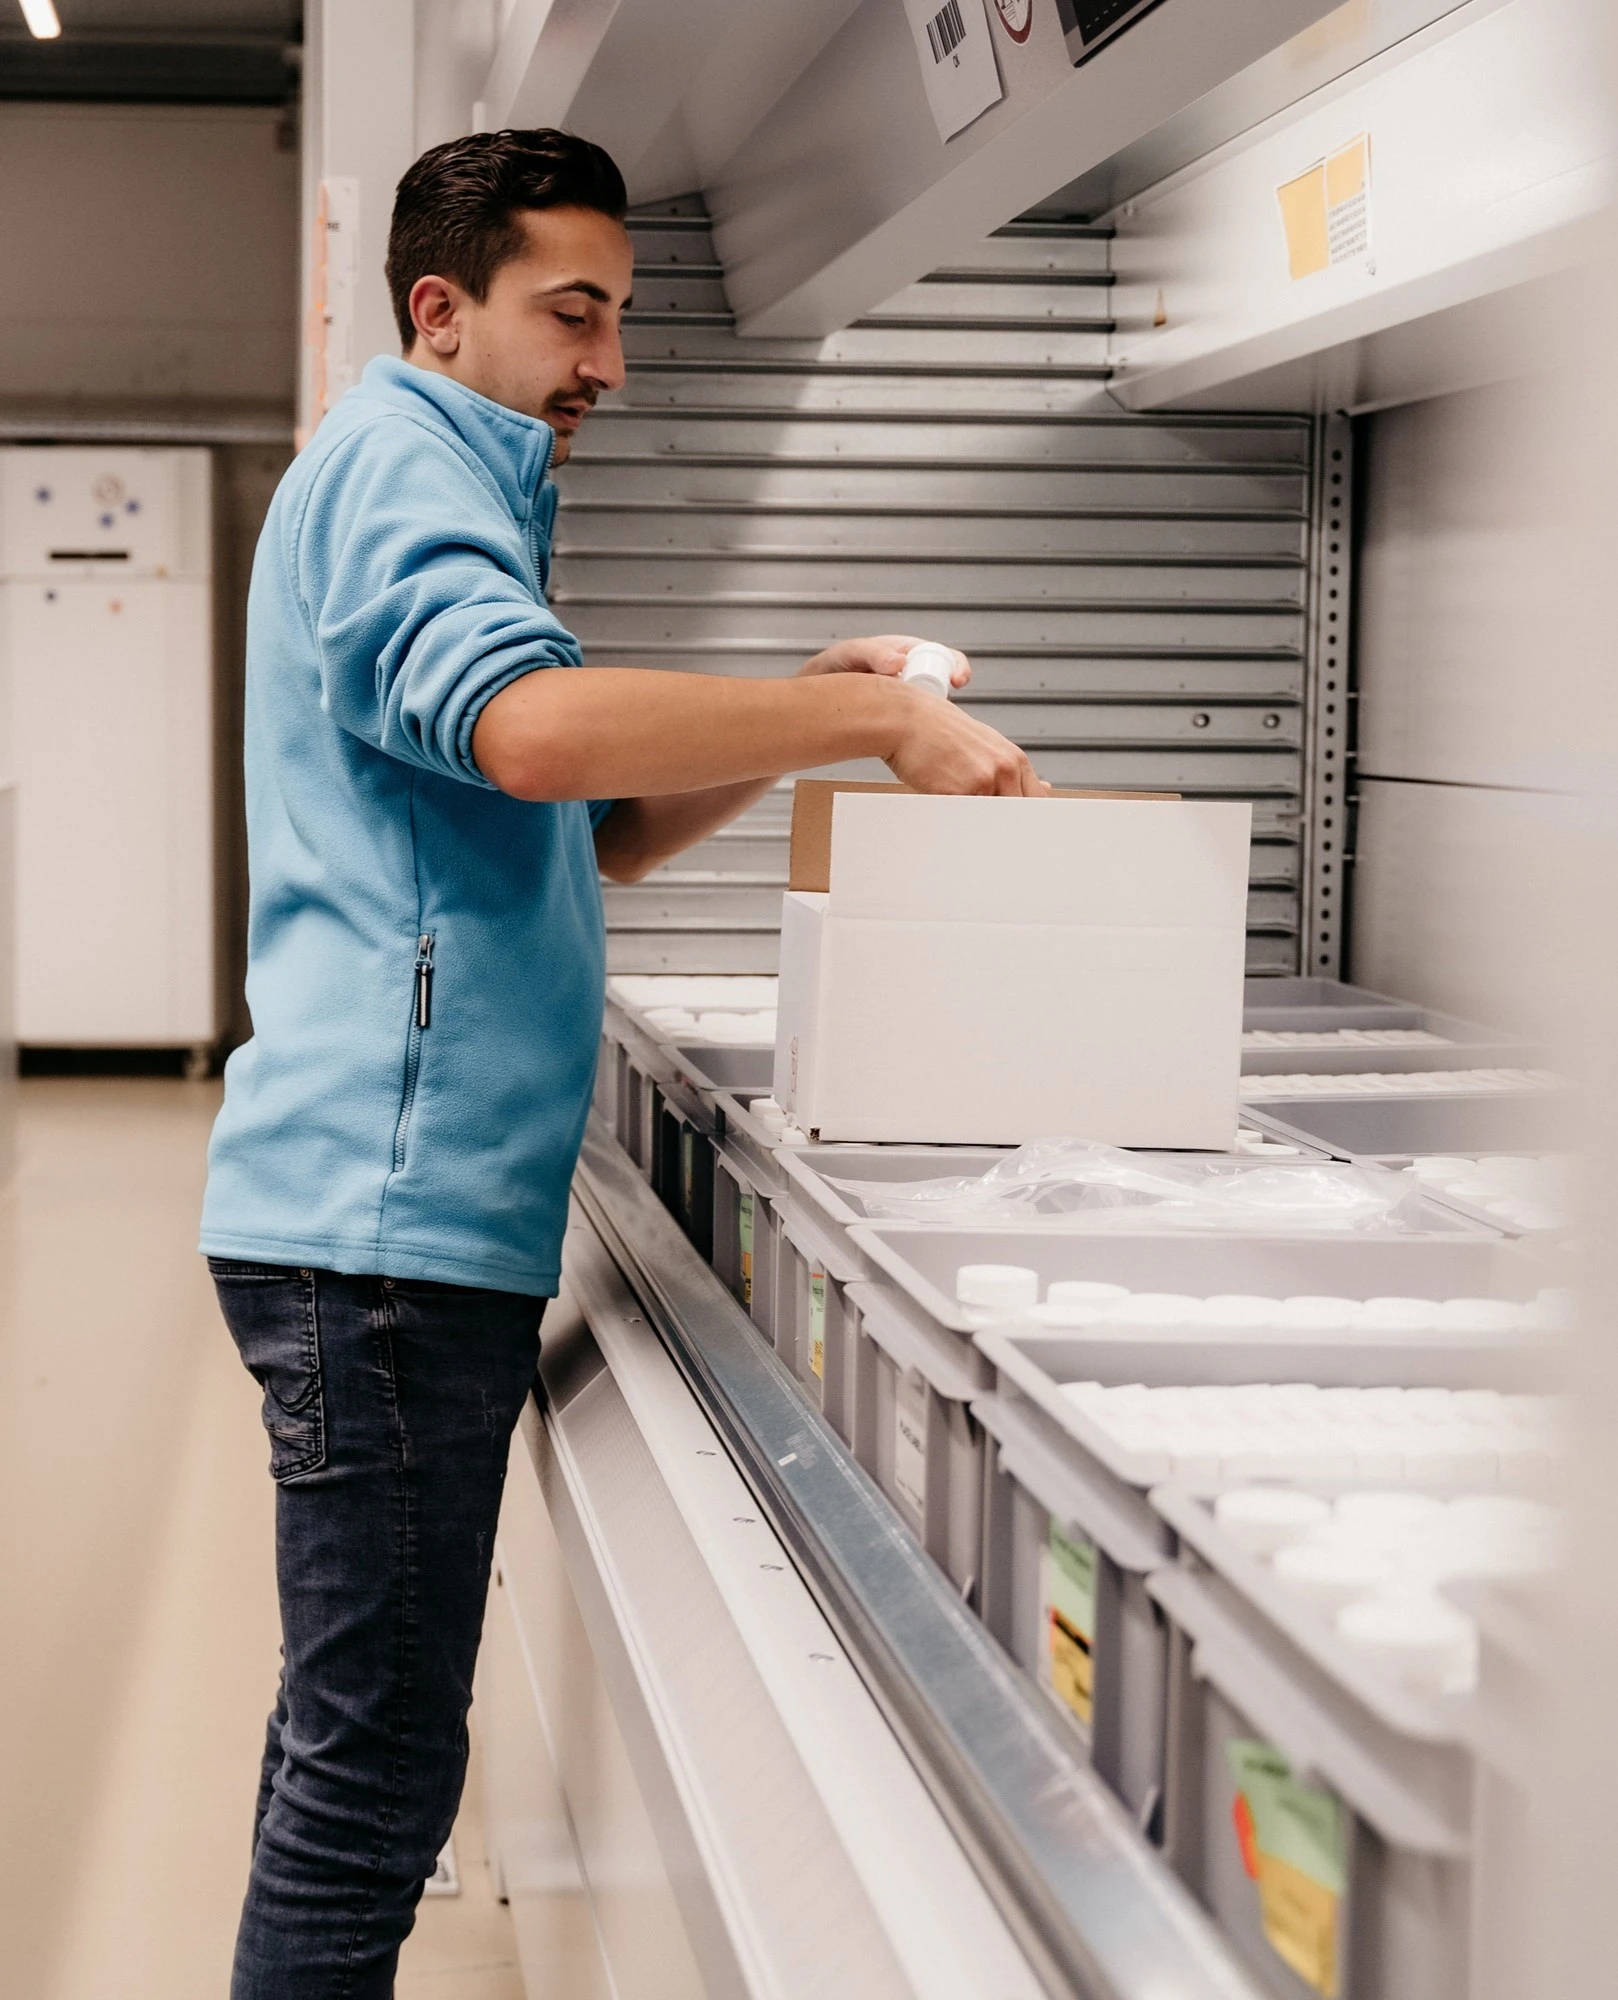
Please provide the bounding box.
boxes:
[1224,1736,1348,2000]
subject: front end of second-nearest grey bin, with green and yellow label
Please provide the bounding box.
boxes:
[972,1396,1172,1838]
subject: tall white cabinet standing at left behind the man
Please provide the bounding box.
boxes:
[0,448,218,1046]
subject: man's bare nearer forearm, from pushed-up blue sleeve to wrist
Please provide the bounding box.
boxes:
[472,666,908,800]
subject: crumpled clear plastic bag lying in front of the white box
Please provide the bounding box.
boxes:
[826,1138,1422,1230]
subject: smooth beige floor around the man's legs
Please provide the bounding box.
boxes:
[0,1080,522,2000]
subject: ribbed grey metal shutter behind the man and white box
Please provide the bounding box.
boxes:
[552,200,1318,972]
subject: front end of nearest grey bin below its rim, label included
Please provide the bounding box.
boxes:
[1148,1568,1480,2000]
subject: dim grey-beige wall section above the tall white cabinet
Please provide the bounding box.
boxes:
[0,104,298,414]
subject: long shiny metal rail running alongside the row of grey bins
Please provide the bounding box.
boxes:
[574,1118,1258,2000]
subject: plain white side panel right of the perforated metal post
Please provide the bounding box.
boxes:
[1352,382,1588,1030]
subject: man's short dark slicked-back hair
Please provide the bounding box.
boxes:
[388,128,630,348]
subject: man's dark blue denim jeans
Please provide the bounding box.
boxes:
[210,1258,546,2000]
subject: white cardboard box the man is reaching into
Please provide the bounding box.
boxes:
[774,792,1252,1150]
